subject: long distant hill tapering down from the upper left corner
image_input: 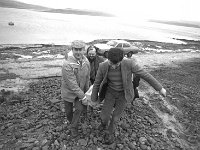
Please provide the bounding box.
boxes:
[0,0,114,17]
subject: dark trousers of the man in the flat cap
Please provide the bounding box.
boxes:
[64,98,87,128]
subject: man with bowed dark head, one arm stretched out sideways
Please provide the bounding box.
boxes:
[91,48,166,144]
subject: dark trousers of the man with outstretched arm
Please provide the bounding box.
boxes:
[101,87,126,134]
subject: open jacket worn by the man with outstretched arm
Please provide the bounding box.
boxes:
[91,58,162,102]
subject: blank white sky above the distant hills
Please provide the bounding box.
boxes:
[16,0,200,21]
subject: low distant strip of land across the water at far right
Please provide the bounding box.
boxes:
[149,20,200,28]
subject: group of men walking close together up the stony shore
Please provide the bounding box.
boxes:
[61,40,166,143]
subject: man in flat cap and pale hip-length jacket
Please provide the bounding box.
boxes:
[61,40,90,137]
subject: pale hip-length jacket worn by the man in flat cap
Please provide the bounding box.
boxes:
[61,51,90,102]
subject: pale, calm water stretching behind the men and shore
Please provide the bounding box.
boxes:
[0,7,200,44]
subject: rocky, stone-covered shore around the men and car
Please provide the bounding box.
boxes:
[0,40,200,150]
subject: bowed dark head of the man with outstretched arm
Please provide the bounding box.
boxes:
[108,48,124,64]
